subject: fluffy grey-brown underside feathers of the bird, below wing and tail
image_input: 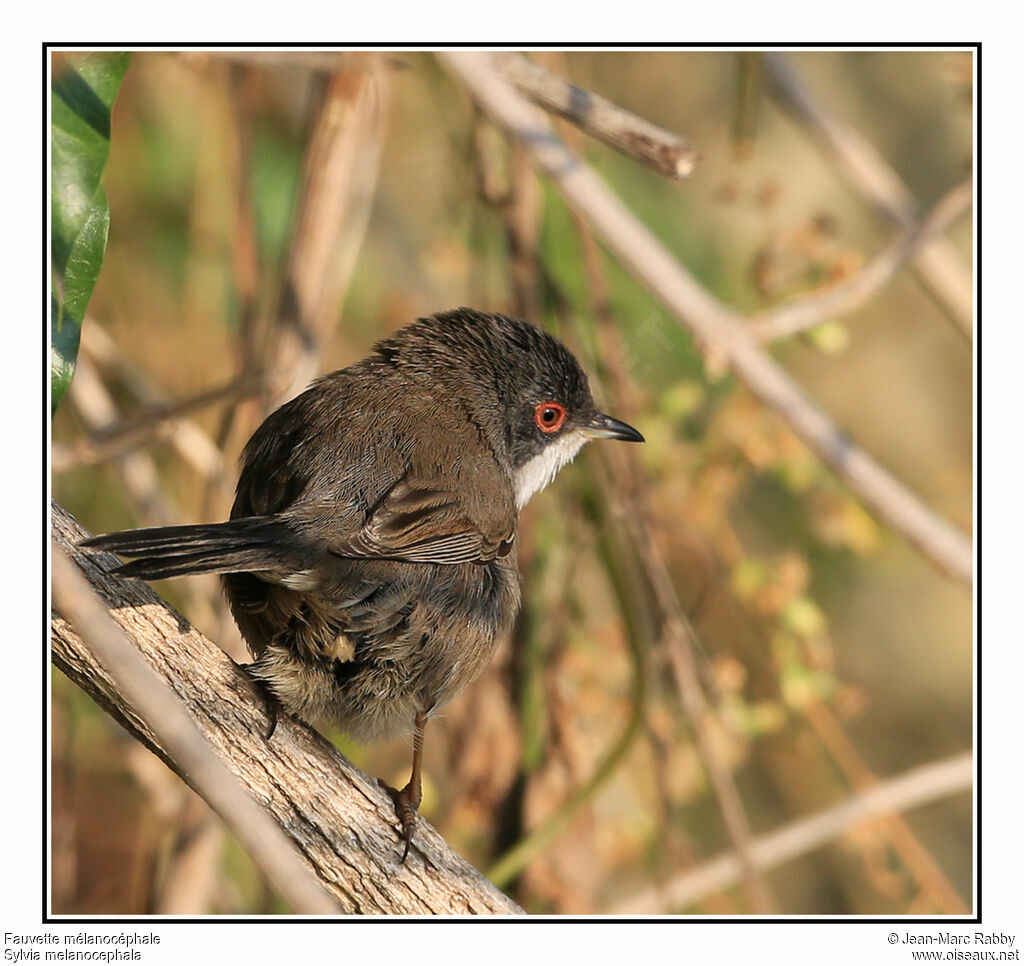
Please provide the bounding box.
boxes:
[241,553,519,742]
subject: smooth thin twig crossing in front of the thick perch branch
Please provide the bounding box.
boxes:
[51,543,340,915]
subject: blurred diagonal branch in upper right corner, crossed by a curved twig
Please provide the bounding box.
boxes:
[761,51,974,338]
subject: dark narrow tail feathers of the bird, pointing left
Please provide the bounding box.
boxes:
[81,516,299,580]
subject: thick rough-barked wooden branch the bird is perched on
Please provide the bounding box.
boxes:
[51,504,522,915]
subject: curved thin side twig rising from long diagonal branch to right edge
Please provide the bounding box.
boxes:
[748,178,974,342]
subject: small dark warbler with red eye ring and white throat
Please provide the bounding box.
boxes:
[83,308,643,862]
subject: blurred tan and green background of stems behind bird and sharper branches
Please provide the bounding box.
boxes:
[52,50,974,916]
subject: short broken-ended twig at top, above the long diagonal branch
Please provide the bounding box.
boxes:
[493,53,697,179]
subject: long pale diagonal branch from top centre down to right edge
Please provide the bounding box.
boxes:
[438,51,973,585]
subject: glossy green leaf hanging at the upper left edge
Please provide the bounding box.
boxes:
[50,52,131,412]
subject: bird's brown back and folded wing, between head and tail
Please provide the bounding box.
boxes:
[231,363,515,564]
